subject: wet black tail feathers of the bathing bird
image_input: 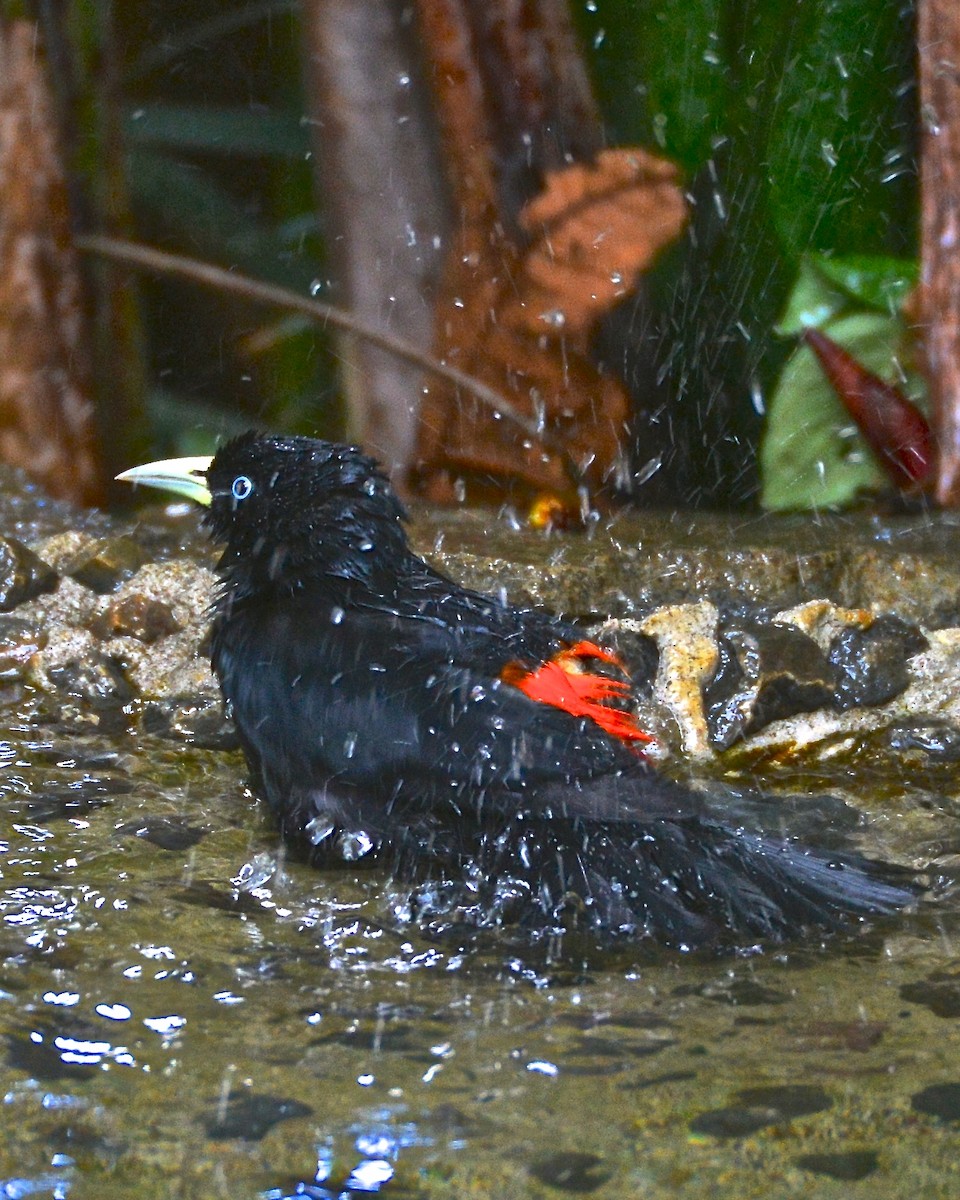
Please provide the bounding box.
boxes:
[501,817,917,947]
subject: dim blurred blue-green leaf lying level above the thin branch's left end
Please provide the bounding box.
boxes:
[124,103,310,158]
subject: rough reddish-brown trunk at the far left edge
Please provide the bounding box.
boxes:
[0,20,103,504]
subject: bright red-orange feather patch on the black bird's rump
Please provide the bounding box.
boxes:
[500,642,653,743]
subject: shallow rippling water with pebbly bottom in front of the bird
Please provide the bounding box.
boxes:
[0,697,960,1200]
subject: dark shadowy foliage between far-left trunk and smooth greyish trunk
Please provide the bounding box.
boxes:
[120,0,341,454]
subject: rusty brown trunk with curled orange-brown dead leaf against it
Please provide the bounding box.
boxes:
[408,0,686,500]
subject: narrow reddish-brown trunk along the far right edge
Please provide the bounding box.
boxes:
[917,0,960,508]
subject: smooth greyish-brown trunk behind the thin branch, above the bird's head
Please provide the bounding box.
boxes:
[301,0,446,473]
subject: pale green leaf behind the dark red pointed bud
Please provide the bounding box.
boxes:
[761,312,923,509]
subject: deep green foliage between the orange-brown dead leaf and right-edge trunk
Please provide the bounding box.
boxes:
[577,0,917,503]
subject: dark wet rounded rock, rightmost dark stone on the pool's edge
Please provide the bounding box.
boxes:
[829,614,930,709]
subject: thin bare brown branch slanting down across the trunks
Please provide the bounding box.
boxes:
[74,234,581,465]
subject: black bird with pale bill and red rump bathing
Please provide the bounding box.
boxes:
[120,433,914,947]
